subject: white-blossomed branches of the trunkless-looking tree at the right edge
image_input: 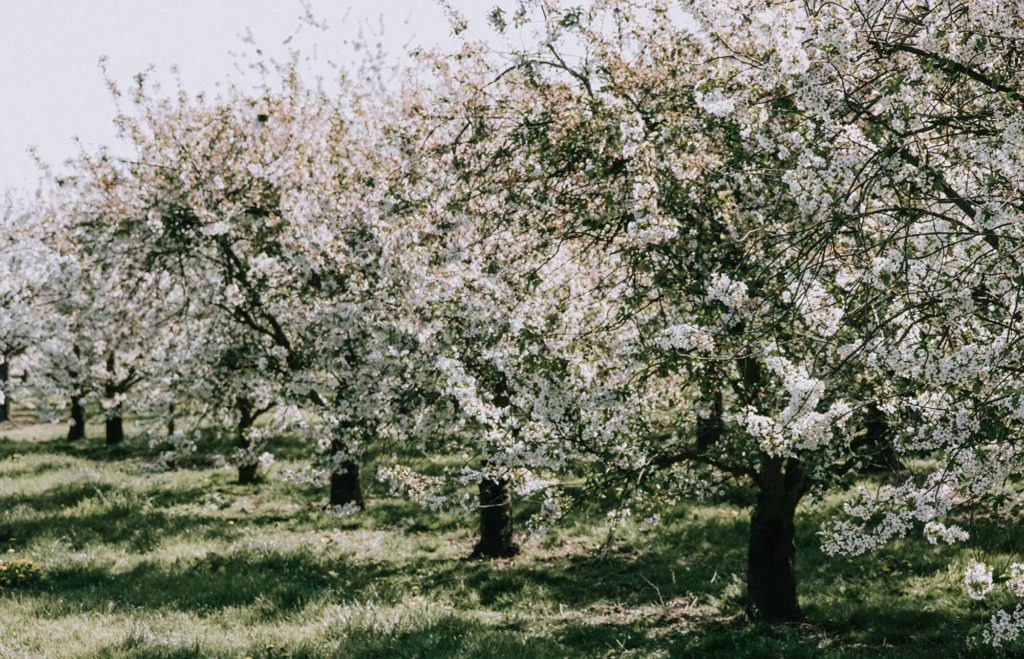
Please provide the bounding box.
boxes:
[688,0,1024,645]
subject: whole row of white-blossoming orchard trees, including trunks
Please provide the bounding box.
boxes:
[0,0,1024,645]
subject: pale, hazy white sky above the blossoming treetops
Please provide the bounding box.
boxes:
[0,0,498,189]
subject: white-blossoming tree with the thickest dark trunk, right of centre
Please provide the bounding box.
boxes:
[407,2,921,620]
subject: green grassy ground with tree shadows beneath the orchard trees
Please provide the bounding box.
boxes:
[0,411,1019,658]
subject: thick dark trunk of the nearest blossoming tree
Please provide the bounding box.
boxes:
[746,455,803,622]
